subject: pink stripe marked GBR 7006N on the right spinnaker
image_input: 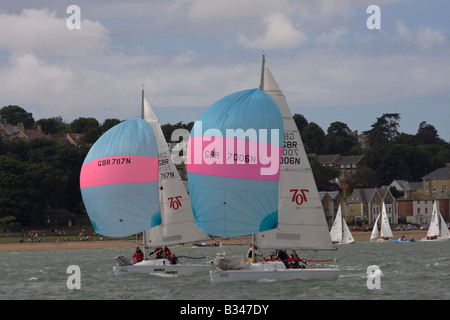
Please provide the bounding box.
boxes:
[187,137,283,181]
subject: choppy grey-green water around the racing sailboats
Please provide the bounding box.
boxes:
[0,241,450,300]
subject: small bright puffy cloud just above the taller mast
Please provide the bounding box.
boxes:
[239,13,306,50]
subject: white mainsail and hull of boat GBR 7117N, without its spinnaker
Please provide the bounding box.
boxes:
[113,90,211,276]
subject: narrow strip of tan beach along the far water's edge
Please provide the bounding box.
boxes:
[0,230,427,252]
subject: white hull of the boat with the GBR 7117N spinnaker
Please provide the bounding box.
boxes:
[113,259,211,276]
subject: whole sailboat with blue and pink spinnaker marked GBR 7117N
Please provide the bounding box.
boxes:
[80,91,210,275]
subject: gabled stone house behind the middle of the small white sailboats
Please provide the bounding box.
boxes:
[345,187,398,224]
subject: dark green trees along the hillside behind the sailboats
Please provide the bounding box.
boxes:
[0,106,450,228]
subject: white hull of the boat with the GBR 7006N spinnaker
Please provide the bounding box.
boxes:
[210,263,340,282]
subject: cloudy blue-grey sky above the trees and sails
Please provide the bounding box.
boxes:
[0,0,450,141]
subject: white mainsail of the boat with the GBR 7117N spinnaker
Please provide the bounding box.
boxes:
[142,91,210,248]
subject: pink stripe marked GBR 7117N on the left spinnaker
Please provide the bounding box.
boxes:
[80,156,158,188]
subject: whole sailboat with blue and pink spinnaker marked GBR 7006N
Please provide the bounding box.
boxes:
[188,56,340,282]
